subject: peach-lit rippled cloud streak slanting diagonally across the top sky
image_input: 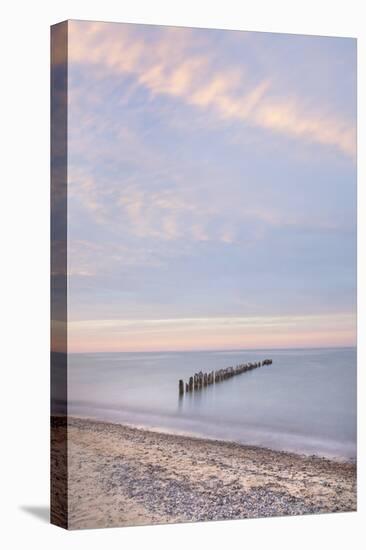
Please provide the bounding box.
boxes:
[69,22,356,158]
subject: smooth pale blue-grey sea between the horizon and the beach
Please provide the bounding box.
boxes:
[68,348,356,458]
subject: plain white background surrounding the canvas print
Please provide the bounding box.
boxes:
[0,0,366,550]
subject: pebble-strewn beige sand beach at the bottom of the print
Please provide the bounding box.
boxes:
[52,418,356,529]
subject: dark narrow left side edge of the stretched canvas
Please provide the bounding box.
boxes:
[50,22,68,528]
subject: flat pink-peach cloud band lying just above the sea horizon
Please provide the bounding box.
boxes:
[69,313,356,351]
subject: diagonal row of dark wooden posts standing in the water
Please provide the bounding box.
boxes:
[178,359,272,395]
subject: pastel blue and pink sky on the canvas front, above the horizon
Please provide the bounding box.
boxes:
[68,21,356,352]
